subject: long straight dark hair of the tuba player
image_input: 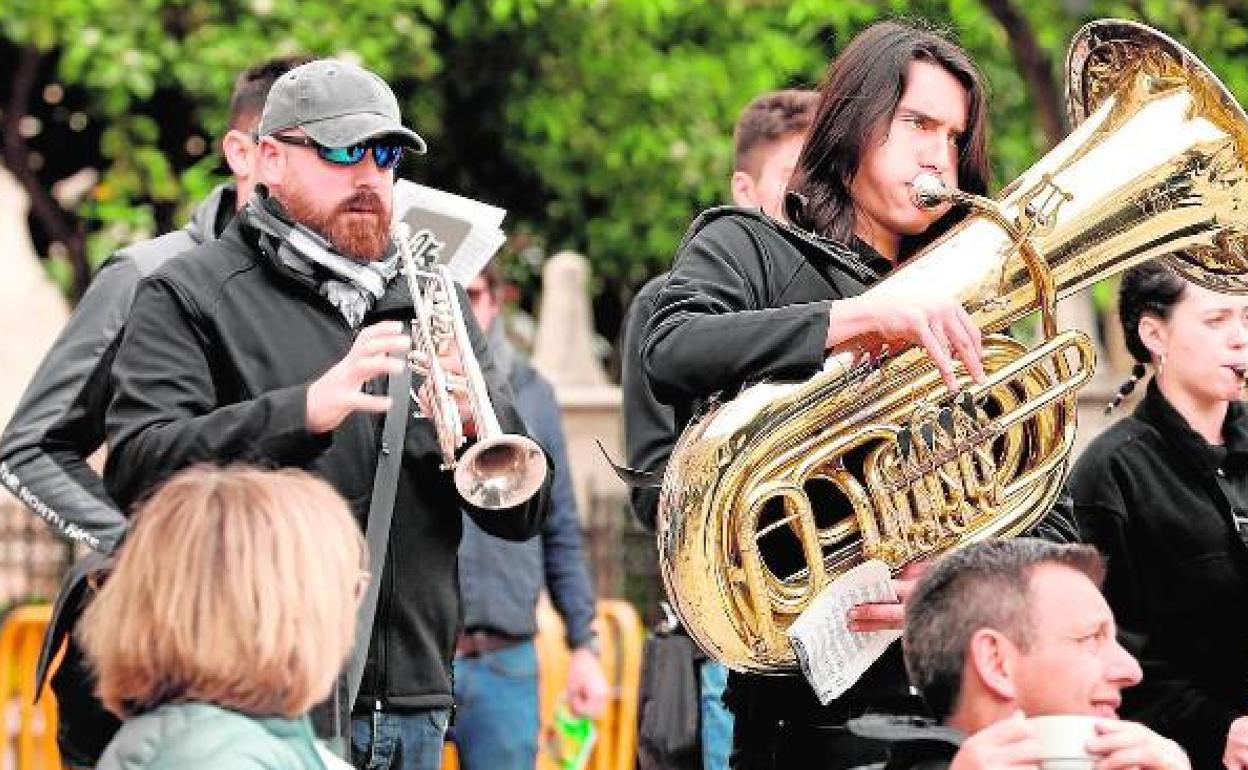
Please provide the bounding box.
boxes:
[792,21,988,255]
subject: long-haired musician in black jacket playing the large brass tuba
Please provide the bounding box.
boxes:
[641,16,1073,769]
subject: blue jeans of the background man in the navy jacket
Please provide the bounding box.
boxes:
[447,640,538,770]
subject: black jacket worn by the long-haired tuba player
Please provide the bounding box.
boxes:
[641,207,1078,768]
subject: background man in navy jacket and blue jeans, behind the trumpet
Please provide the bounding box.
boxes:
[449,265,609,770]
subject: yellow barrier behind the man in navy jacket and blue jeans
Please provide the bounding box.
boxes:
[442,598,645,770]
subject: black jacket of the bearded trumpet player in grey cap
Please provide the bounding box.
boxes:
[105,213,549,709]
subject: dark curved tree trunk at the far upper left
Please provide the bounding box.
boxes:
[0,45,91,298]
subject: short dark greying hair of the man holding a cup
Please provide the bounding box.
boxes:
[902,538,1104,720]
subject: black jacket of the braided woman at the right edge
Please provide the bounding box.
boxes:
[1071,382,1248,768]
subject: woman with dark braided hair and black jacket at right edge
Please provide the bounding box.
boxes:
[1070,261,1248,770]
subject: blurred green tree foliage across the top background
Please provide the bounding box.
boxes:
[0,0,1248,311]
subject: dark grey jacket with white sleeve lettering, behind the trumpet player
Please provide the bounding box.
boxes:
[0,187,235,553]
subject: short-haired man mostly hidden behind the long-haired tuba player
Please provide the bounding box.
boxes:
[620,90,819,770]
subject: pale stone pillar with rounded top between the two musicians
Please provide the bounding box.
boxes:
[533,251,626,518]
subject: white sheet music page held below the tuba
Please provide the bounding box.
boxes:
[787,559,901,705]
